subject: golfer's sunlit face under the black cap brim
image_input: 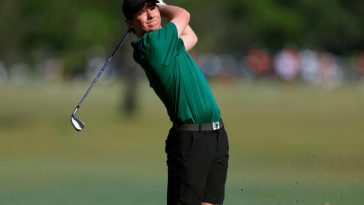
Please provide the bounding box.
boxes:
[127,3,161,36]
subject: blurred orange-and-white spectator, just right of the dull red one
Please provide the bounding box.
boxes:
[274,47,300,81]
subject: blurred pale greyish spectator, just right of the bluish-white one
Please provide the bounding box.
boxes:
[318,52,342,88]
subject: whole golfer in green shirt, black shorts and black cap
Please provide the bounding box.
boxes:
[122,0,229,205]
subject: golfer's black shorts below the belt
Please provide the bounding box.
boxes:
[165,128,229,205]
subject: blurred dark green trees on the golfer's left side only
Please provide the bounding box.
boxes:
[0,0,124,74]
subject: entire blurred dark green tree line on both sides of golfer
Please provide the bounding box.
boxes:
[0,0,364,75]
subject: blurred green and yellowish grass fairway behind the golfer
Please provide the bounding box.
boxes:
[0,83,364,205]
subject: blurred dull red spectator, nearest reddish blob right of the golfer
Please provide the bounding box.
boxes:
[244,48,271,78]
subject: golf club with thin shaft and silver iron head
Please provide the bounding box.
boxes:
[71,30,130,131]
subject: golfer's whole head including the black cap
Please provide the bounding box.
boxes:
[123,0,161,36]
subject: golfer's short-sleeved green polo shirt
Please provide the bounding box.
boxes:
[131,22,220,124]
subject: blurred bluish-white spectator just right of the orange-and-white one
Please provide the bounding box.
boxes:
[299,49,318,83]
